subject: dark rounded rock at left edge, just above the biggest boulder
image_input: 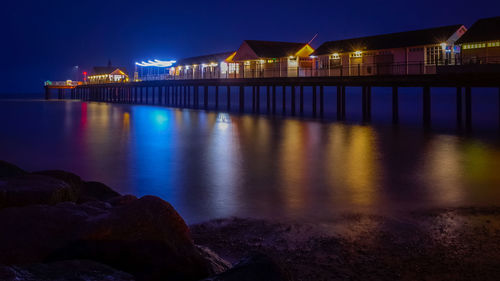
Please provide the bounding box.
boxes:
[0,175,77,209]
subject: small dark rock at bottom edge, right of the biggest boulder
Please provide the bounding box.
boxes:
[204,253,293,281]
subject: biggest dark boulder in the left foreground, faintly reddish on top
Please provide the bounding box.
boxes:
[0,196,211,280]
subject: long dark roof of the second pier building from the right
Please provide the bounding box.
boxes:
[313,24,463,55]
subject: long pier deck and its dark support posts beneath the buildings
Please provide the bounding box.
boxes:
[45,73,500,129]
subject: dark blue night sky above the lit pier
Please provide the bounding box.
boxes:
[0,0,500,93]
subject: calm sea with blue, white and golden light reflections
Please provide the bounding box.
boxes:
[0,93,500,223]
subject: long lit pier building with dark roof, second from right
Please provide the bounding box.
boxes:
[313,25,467,76]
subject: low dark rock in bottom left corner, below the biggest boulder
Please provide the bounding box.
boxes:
[0,260,134,281]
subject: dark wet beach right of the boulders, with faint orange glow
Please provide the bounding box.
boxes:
[191,207,500,280]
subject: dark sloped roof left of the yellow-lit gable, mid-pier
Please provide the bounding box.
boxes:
[240,40,307,58]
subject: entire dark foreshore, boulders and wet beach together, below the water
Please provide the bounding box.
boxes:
[0,161,500,281]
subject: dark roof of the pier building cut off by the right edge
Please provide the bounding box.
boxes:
[456,17,500,44]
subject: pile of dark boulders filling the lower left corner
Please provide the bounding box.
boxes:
[0,161,287,281]
